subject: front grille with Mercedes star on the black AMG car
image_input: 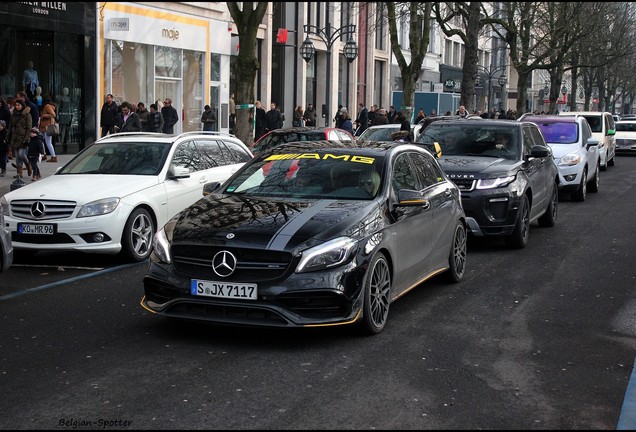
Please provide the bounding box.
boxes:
[171,246,292,282]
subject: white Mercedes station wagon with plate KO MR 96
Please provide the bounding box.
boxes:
[0,132,252,261]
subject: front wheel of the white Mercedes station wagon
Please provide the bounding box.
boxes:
[121,208,155,262]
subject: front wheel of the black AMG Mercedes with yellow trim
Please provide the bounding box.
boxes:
[361,252,391,335]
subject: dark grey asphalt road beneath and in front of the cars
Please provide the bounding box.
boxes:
[0,156,636,430]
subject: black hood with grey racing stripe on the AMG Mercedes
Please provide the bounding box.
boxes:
[172,195,378,251]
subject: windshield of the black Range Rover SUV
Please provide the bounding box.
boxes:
[417,121,521,160]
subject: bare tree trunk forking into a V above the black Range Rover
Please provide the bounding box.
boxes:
[383,2,432,119]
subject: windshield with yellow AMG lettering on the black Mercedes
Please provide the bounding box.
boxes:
[225,149,384,199]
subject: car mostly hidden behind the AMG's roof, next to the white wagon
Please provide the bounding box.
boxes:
[252,126,355,155]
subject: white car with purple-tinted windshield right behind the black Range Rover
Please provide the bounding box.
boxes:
[520,115,601,201]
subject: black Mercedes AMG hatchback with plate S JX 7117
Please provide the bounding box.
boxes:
[141,141,466,334]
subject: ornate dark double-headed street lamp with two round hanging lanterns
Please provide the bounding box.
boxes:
[300,24,358,126]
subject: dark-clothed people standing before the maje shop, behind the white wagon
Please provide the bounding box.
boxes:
[99,93,179,136]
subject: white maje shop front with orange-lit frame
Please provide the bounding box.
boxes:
[99,2,231,133]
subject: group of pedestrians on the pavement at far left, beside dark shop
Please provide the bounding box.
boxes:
[0,90,59,181]
